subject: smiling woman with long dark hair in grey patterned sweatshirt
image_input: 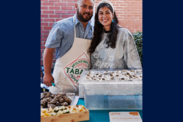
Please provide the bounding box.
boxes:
[89,0,141,69]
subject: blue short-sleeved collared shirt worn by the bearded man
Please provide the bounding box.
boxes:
[45,14,92,59]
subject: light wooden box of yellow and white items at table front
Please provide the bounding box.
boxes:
[41,105,89,122]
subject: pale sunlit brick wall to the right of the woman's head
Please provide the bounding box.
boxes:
[95,0,142,33]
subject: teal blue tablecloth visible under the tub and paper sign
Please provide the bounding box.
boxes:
[77,98,143,122]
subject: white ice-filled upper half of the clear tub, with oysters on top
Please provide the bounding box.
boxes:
[79,69,142,98]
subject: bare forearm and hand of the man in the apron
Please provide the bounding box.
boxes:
[43,48,55,86]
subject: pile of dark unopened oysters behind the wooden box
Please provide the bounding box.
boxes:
[41,92,72,108]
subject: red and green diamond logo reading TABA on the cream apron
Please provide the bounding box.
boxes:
[64,52,90,89]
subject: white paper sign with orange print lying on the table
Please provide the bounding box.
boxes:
[109,112,142,122]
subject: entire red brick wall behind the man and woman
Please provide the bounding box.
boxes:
[40,0,142,64]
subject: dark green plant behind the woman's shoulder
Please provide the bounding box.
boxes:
[133,31,143,64]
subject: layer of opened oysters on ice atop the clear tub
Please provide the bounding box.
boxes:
[85,70,142,81]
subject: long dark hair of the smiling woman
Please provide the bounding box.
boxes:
[88,3,118,54]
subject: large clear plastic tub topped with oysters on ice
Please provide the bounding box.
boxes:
[79,69,142,110]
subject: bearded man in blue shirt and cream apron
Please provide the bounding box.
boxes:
[43,0,94,94]
